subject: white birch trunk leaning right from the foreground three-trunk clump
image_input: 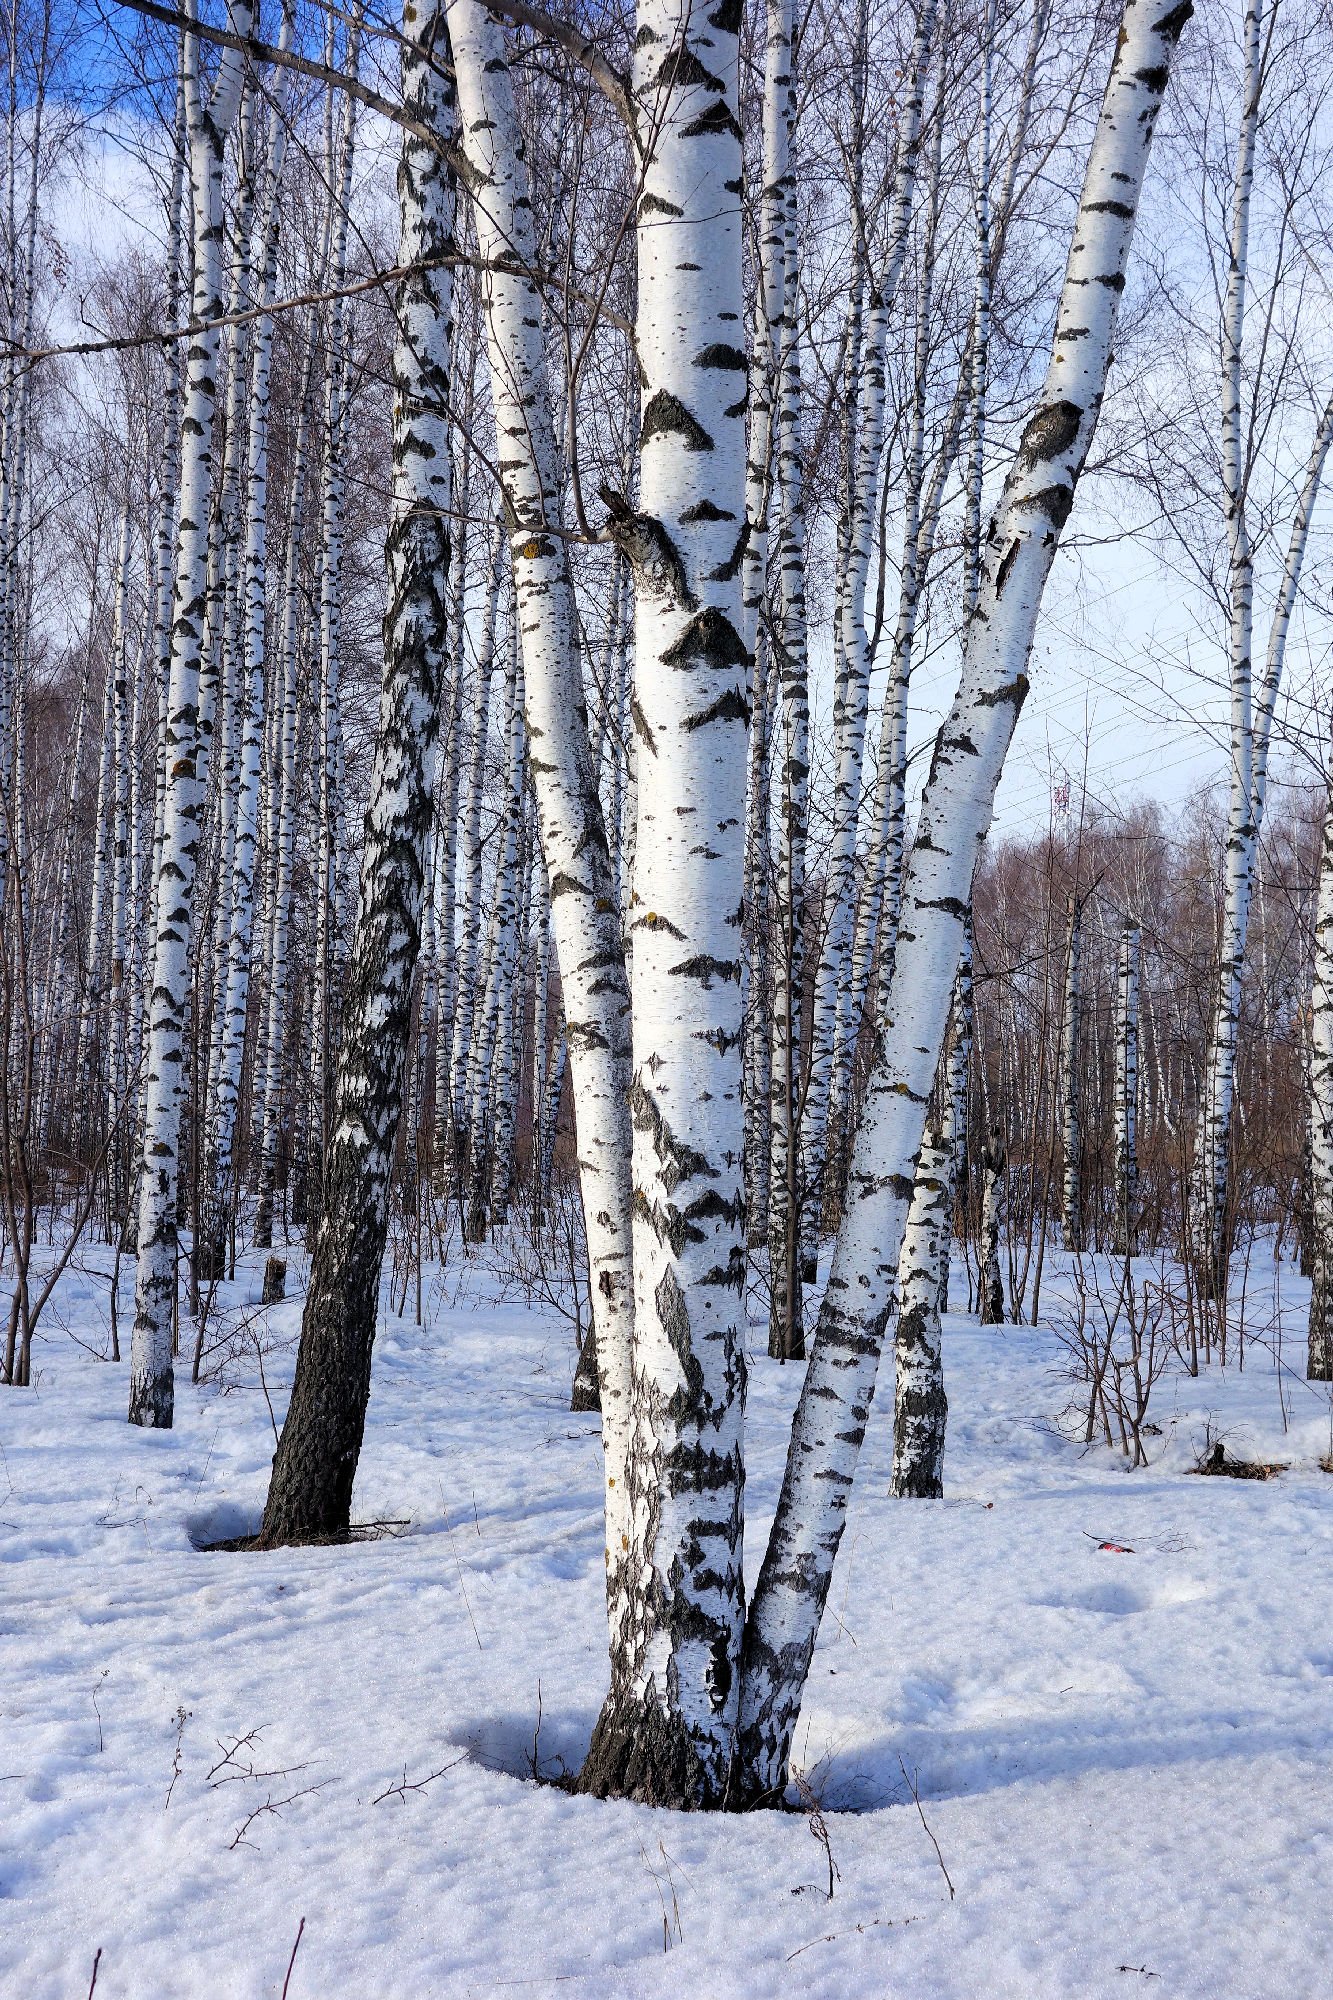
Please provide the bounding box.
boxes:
[733,0,1189,1798]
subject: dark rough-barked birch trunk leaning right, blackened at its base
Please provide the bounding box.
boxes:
[260,0,454,1546]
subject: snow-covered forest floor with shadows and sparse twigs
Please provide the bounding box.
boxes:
[0,1224,1333,2000]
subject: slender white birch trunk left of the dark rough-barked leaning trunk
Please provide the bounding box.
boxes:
[128,0,254,1428]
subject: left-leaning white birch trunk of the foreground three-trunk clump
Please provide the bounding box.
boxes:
[448,0,636,1644]
